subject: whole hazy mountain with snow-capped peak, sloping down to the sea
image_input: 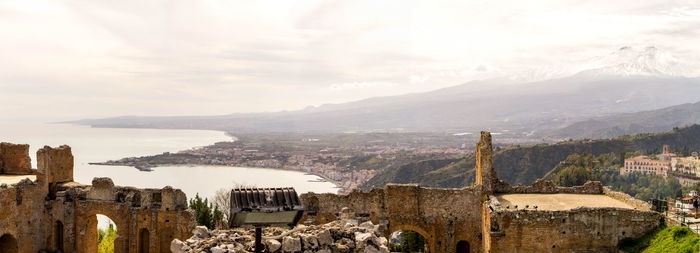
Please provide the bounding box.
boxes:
[74,47,700,138]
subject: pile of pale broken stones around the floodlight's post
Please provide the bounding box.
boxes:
[170,219,389,253]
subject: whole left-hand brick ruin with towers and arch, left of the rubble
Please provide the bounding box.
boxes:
[0,143,195,253]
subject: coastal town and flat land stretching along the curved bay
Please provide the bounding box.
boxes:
[93,132,469,193]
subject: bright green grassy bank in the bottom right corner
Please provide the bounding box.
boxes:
[619,227,700,253]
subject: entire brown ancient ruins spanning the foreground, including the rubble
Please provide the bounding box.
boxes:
[0,132,663,253]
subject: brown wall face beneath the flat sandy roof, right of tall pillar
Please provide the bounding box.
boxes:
[485,208,663,252]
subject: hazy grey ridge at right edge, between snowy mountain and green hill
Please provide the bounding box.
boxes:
[548,102,700,139]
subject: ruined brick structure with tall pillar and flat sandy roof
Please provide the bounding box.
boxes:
[301,132,663,253]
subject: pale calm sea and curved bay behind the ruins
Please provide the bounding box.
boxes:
[0,122,338,201]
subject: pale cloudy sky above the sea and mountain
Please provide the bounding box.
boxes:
[0,0,700,121]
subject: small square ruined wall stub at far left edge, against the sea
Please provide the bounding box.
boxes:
[0,142,32,174]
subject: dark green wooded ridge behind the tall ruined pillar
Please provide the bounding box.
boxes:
[363,125,700,189]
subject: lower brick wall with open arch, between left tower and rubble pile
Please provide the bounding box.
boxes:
[50,178,195,252]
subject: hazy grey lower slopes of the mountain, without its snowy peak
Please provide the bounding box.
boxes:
[74,76,700,135]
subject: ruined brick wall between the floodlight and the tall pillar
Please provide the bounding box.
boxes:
[300,184,482,252]
